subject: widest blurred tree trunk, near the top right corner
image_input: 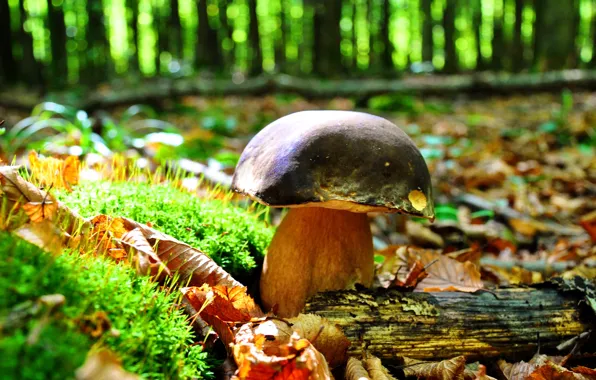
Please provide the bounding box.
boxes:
[537,0,577,70]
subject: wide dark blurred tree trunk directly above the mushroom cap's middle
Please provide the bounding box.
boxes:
[313,0,342,77]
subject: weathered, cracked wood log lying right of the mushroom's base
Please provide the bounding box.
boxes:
[305,288,596,360]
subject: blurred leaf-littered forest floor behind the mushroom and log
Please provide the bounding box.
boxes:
[0,91,596,378]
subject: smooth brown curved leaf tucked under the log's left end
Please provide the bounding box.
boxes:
[287,314,350,368]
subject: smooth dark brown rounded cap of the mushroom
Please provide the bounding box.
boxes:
[232,111,434,219]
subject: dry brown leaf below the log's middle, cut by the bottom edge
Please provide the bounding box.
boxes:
[404,356,466,380]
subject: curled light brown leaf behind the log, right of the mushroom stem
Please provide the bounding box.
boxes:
[397,248,484,292]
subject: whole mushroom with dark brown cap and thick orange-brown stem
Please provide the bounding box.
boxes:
[232,111,434,317]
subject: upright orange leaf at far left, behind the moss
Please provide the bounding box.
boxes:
[29,151,80,191]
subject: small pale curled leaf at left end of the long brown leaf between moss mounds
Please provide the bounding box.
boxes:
[120,228,171,279]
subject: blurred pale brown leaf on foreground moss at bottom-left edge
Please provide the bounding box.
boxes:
[75,350,140,380]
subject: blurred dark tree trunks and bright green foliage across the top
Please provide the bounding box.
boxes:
[0,0,596,91]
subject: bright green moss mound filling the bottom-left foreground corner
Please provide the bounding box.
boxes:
[0,232,212,379]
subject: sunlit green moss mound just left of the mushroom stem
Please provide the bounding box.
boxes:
[59,182,274,283]
